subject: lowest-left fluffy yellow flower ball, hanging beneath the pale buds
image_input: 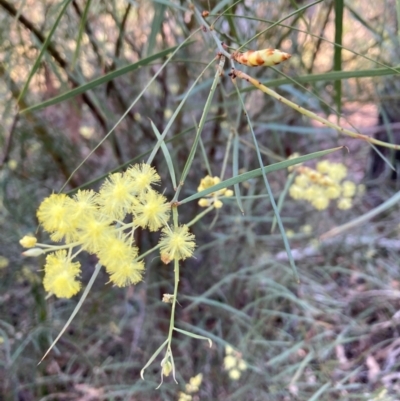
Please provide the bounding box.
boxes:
[43,250,81,298]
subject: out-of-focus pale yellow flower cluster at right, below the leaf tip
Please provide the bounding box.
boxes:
[289,160,357,210]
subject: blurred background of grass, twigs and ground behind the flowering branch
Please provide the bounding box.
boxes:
[0,0,400,401]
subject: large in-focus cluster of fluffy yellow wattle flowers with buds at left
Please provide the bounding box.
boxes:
[20,164,195,298]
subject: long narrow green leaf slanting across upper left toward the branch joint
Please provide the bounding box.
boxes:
[21,41,194,113]
